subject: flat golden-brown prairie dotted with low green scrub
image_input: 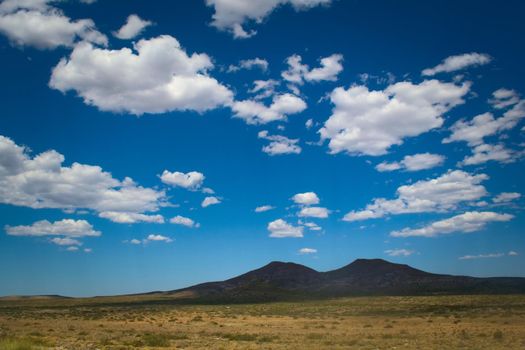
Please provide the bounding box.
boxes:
[0,295,525,350]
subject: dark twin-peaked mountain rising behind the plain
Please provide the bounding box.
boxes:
[165,259,525,302]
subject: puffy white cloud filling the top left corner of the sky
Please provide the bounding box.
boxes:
[0,0,108,49]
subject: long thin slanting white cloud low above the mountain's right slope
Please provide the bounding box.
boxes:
[390,211,513,237]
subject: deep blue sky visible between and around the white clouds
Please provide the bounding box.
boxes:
[0,0,525,296]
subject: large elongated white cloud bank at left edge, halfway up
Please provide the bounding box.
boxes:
[0,136,165,220]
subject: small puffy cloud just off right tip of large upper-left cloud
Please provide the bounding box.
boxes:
[232,93,307,124]
